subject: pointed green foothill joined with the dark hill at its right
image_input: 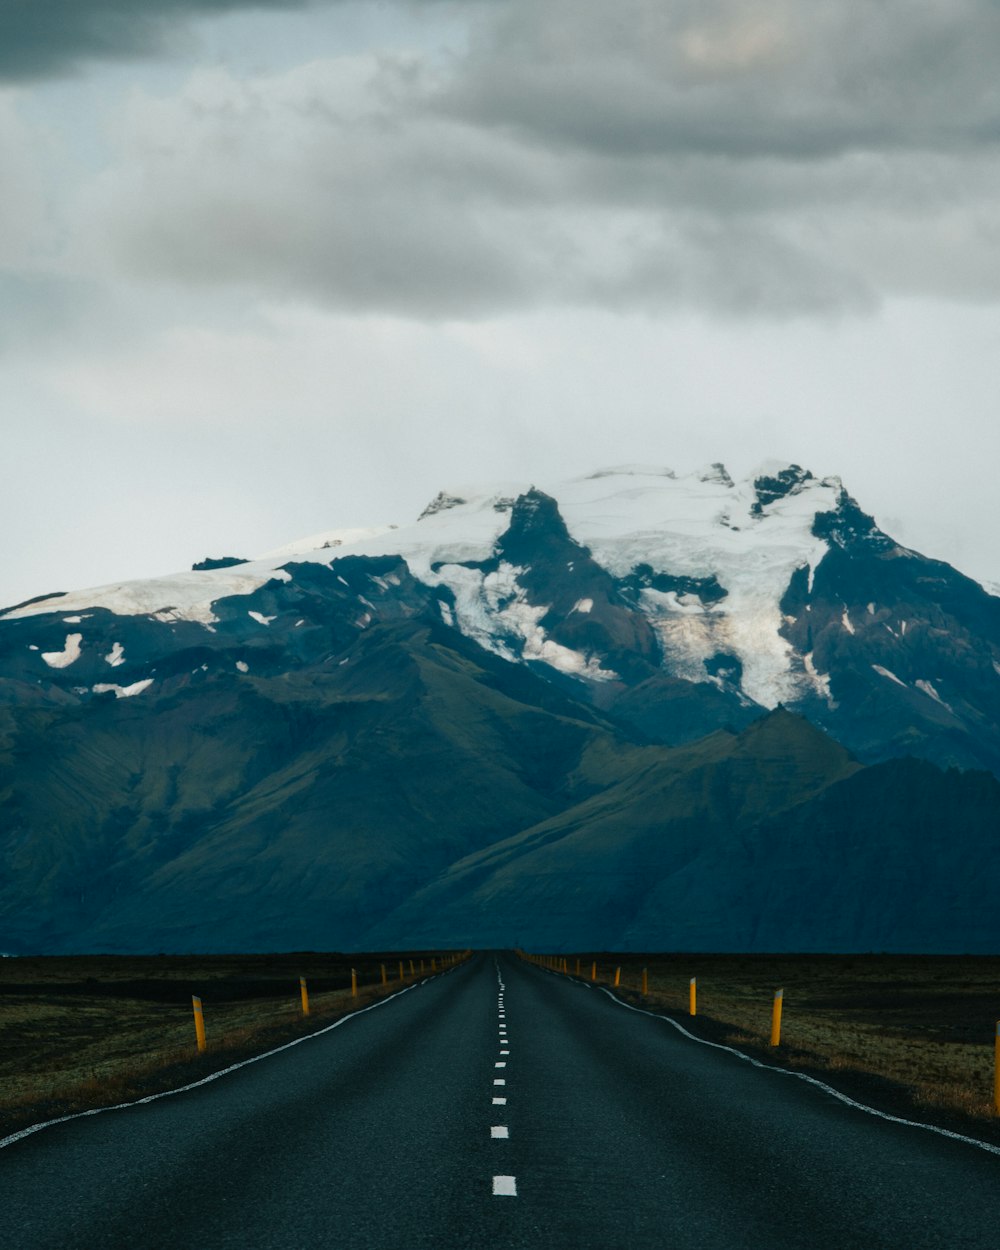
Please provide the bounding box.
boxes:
[362,713,1000,953]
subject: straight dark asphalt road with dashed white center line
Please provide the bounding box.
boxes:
[0,955,1000,1250]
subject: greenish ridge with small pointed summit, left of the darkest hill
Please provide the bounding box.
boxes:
[362,711,860,949]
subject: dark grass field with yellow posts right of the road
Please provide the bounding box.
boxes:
[530,951,1000,1141]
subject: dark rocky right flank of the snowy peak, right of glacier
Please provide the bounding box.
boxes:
[781,494,1000,775]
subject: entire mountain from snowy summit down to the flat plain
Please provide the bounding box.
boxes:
[0,465,1000,951]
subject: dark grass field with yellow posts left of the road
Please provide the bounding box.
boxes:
[0,951,455,1136]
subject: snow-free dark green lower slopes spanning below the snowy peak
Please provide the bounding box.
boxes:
[0,615,1000,953]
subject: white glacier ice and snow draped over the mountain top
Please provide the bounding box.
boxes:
[5,461,875,708]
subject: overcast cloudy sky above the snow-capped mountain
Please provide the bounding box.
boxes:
[0,0,1000,605]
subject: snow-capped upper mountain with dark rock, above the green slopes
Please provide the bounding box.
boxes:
[0,461,1000,766]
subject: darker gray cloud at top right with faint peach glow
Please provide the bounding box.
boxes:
[433,0,1000,160]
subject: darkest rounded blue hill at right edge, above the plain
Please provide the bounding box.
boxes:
[725,759,1000,954]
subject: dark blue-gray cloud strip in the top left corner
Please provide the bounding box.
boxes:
[0,0,310,81]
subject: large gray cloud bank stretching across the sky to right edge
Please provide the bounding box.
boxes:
[58,0,1000,319]
